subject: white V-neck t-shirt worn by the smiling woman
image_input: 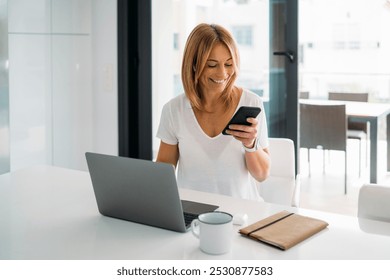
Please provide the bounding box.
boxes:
[157,90,268,200]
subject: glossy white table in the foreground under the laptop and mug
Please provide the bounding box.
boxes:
[0,166,390,260]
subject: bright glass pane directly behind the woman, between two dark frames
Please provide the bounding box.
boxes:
[152,0,269,157]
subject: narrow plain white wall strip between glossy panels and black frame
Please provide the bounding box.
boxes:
[92,0,118,155]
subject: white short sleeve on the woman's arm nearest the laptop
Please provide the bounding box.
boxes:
[156,102,178,145]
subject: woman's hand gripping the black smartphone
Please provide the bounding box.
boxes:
[226,118,258,148]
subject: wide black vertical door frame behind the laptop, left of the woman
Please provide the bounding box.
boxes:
[117,0,153,160]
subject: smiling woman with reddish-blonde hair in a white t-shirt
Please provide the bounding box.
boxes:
[157,23,270,200]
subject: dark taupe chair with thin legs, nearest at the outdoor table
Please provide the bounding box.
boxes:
[299,103,347,194]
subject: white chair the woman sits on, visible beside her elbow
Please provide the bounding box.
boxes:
[257,138,300,207]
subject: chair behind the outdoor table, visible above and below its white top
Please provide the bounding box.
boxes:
[328,92,369,177]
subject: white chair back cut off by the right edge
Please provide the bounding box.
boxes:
[358,184,390,222]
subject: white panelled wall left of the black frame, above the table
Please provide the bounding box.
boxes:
[8,0,118,170]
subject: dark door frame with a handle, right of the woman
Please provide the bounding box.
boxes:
[267,0,299,174]
